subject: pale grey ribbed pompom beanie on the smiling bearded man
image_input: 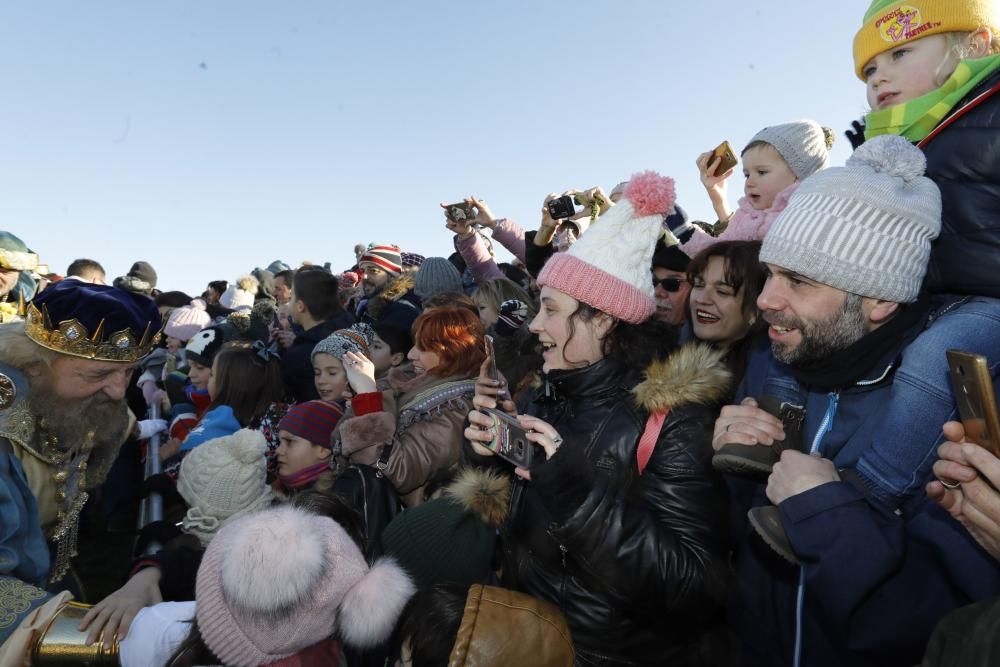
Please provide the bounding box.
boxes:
[760,134,941,303]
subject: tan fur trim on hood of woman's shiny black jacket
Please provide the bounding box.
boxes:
[632,343,733,413]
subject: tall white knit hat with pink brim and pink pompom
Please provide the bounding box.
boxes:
[538,171,675,324]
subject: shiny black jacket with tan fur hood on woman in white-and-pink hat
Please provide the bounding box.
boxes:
[502,346,730,666]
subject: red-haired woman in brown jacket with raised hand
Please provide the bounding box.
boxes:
[333,307,486,507]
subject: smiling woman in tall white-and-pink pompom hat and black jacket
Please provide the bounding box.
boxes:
[465,172,730,665]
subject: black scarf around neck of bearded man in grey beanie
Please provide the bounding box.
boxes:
[792,294,929,391]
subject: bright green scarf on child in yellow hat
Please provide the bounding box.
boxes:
[865,54,1000,142]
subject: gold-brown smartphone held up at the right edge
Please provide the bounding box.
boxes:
[945,350,1000,457]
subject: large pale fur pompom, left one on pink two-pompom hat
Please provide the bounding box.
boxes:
[222,507,326,613]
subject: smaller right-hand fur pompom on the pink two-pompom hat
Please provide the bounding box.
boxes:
[338,558,417,648]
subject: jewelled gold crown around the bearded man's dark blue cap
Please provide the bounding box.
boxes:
[24,303,160,362]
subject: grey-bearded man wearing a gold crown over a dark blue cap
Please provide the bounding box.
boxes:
[0,280,160,665]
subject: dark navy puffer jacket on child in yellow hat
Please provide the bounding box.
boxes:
[921,72,1000,297]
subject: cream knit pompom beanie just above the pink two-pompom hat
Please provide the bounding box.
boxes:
[177,429,273,544]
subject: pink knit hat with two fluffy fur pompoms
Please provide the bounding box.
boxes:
[196,507,415,666]
